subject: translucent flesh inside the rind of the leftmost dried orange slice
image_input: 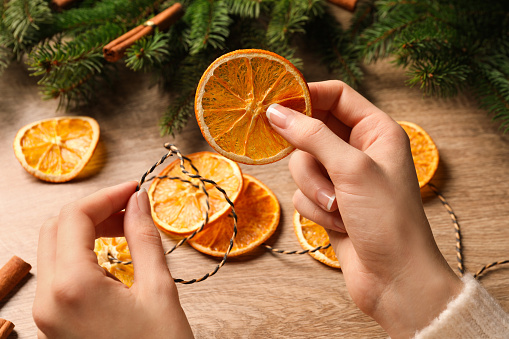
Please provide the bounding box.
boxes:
[21,119,93,175]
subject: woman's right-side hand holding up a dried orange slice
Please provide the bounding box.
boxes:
[267,81,462,338]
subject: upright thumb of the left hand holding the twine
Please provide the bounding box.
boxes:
[124,188,173,286]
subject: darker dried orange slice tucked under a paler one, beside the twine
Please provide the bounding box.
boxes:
[188,174,280,257]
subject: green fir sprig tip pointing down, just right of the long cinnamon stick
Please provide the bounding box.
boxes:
[183,0,232,55]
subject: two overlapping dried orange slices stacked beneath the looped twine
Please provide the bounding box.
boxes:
[148,152,280,257]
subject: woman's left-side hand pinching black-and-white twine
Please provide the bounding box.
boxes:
[33,182,193,338]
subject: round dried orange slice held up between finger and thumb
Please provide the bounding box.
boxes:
[194,49,311,164]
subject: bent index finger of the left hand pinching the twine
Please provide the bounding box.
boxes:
[57,181,137,269]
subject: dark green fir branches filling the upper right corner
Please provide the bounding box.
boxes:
[359,0,509,125]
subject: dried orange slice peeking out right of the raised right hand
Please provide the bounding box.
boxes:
[398,121,440,188]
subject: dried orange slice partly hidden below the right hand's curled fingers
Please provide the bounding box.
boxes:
[293,211,340,268]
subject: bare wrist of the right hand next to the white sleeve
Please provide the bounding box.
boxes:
[373,249,463,338]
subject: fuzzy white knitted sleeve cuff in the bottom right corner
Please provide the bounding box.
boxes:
[415,274,509,339]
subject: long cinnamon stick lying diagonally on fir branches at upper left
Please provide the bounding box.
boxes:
[103,2,183,62]
